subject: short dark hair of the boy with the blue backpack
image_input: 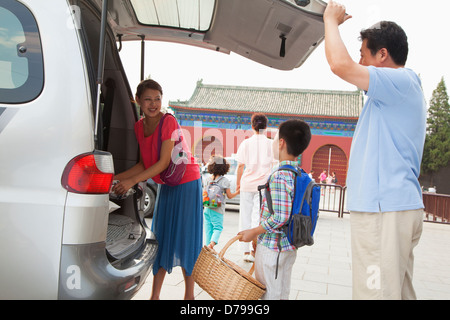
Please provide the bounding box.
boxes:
[278,119,311,157]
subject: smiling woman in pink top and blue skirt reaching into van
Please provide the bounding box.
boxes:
[114,80,203,299]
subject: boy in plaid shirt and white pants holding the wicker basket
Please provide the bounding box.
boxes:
[238,120,311,300]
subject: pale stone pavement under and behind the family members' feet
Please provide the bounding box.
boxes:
[133,210,450,300]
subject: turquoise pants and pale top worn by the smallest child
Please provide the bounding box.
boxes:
[203,175,231,245]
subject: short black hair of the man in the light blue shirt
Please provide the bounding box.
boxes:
[360,21,409,66]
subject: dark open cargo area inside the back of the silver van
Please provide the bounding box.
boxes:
[72,1,157,268]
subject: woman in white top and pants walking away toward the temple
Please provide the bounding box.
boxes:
[236,113,275,262]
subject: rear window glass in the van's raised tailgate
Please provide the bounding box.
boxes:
[131,0,215,31]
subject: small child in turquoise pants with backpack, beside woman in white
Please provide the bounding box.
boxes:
[203,156,239,249]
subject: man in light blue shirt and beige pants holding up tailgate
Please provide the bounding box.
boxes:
[324,0,426,299]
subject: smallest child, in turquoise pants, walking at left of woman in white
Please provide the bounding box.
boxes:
[203,156,239,249]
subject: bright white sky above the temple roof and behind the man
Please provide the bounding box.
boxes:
[120,0,450,106]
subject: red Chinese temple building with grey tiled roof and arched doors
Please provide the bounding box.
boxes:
[169,81,364,185]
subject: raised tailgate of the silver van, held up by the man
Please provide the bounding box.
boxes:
[95,0,326,70]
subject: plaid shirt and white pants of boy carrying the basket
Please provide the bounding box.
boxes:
[255,161,297,299]
